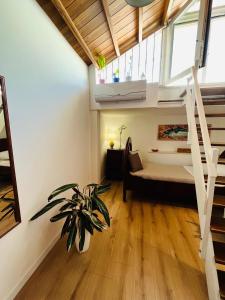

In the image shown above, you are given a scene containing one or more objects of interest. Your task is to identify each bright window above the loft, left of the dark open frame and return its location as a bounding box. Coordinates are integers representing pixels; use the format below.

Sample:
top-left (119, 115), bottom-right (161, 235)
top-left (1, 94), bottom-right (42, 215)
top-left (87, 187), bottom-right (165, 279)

top-left (170, 1), bottom-right (200, 77)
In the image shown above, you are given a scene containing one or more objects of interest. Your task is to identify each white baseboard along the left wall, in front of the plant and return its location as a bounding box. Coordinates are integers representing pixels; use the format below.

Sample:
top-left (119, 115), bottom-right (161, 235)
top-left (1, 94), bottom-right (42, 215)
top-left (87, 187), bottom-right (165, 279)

top-left (6, 234), bottom-right (59, 300)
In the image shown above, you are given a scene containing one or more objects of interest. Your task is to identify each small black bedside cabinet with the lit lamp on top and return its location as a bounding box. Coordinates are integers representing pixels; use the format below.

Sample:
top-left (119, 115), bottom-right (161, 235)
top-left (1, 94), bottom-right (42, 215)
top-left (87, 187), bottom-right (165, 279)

top-left (106, 149), bottom-right (124, 179)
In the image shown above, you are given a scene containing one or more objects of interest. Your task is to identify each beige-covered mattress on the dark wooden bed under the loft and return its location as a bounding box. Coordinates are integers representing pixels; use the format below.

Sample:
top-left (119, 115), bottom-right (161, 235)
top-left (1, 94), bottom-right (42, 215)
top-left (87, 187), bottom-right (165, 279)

top-left (130, 162), bottom-right (194, 184)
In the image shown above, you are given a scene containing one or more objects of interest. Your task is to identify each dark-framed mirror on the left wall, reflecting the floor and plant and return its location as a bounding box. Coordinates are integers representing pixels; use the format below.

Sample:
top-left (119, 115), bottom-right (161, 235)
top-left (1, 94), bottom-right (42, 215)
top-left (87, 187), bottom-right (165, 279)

top-left (0, 76), bottom-right (21, 237)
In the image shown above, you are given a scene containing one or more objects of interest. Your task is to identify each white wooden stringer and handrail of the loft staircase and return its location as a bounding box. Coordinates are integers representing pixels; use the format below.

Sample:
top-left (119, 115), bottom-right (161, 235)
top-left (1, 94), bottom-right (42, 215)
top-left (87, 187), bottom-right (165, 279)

top-left (180, 67), bottom-right (225, 300)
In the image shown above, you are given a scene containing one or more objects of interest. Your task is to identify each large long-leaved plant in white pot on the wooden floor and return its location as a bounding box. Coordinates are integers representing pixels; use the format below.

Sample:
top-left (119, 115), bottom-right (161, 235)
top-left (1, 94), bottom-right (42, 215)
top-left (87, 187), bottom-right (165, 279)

top-left (31, 183), bottom-right (110, 252)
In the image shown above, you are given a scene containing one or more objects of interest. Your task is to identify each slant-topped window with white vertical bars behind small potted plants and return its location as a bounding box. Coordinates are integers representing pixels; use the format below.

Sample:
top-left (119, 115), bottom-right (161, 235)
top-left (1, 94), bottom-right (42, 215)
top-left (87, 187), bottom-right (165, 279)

top-left (96, 31), bottom-right (162, 84)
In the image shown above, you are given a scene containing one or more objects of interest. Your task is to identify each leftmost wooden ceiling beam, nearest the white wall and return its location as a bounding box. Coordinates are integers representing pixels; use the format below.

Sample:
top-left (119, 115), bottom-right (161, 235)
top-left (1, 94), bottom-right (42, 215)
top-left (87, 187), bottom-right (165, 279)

top-left (51, 0), bottom-right (98, 68)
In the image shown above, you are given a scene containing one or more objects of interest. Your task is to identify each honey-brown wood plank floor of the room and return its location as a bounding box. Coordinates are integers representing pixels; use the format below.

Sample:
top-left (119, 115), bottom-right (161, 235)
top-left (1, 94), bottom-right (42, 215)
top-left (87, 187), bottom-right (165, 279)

top-left (16, 183), bottom-right (208, 300)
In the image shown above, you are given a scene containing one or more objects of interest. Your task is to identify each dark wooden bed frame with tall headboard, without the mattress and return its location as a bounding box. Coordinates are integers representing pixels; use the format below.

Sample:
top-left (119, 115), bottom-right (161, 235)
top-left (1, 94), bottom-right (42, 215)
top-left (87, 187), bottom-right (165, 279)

top-left (123, 137), bottom-right (197, 206)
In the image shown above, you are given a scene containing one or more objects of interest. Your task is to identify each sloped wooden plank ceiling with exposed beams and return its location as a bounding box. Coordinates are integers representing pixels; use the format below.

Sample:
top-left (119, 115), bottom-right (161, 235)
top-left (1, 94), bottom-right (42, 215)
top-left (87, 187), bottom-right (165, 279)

top-left (37, 0), bottom-right (190, 66)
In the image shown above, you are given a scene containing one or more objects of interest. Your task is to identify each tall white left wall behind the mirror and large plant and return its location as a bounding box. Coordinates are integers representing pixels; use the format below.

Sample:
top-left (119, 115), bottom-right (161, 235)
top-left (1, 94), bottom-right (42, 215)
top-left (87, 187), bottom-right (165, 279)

top-left (0, 0), bottom-right (90, 300)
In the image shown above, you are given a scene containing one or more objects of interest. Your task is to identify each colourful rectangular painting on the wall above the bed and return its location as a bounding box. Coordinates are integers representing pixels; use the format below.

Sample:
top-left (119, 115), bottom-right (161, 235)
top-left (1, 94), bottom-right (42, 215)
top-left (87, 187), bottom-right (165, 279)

top-left (158, 124), bottom-right (188, 141)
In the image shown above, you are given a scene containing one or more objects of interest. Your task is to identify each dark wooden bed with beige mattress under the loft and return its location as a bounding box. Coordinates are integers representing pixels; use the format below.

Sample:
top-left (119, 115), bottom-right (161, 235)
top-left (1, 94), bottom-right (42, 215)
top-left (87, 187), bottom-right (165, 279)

top-left (123, 137), bottom-right (197, 205)
